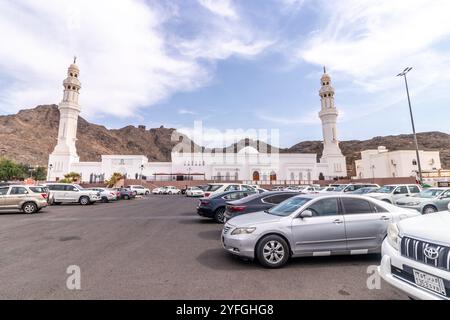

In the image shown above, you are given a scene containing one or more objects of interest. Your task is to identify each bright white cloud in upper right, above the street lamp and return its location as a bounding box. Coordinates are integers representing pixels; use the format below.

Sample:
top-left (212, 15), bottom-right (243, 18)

top-left (297, 0), bottom-right (450, 94)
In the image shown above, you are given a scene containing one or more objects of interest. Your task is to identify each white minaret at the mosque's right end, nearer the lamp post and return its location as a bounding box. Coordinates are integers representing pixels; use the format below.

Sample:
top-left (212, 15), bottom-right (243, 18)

top-left (319, 67), bottom-right (347, 178)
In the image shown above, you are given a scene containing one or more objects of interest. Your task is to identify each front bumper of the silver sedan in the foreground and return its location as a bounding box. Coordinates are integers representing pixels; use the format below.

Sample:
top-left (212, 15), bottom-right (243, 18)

top-left (222, 228), bottom-right (257, 259)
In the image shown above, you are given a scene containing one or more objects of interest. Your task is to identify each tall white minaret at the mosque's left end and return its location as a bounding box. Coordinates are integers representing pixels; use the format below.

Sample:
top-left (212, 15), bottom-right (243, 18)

top-left (47, 58), bottom-right (81, 181)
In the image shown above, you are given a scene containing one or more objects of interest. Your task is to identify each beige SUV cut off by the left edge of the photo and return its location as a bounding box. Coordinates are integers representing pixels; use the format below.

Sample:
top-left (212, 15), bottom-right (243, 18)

top-left (0, 185), bottom-right (48, 214)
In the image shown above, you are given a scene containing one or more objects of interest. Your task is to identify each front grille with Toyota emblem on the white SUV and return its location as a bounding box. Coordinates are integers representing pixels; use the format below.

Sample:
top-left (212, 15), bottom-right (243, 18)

top-left (400, 237), bottom-right (450, 271)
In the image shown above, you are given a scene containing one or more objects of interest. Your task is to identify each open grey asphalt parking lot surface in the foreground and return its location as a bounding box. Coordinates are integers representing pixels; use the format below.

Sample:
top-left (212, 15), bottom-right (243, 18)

top-left (0, 196), bottom-right (406, 300)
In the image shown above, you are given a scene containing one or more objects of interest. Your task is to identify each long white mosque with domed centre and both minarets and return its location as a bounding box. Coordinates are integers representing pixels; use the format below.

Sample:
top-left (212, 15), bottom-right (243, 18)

top-left (47, 61), bottom-right (347, 183)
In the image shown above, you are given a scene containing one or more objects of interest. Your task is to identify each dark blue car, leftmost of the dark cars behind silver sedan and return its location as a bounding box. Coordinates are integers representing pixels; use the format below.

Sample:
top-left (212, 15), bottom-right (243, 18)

top-left (197, 190), bottom-right (255, 223)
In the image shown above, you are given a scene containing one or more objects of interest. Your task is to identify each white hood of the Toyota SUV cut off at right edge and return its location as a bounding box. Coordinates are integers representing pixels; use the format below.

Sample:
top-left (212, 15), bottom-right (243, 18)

top-left (398, 211), bottom-right (450, 245)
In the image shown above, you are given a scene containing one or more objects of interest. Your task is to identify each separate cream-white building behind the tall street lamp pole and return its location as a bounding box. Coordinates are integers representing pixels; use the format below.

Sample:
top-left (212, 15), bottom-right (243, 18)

top-left (355, 147), bottom-right (441, 179)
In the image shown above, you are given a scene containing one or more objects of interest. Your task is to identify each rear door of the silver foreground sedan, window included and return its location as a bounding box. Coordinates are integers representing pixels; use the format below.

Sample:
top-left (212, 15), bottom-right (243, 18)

top-left (341, 197), bottom-right (392, 253)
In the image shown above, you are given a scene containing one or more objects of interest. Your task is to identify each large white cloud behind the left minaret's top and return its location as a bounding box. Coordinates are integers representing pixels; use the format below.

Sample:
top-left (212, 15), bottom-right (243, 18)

top-left (0, 0), bottom-right (265, 117)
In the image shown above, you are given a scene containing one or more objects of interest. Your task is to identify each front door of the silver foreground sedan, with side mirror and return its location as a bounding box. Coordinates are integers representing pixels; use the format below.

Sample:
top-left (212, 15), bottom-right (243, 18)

top-left (292, 197), bottom-right (346, 256)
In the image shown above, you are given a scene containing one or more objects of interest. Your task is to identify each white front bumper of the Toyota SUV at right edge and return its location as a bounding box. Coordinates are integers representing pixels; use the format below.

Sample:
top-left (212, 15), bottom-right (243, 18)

top-left (378, 240), bottom-right (450, 300)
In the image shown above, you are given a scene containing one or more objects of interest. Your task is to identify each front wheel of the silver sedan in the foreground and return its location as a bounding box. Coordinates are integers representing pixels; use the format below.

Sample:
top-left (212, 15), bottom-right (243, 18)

top-left (256, 235), bottom-right (290, 268)
